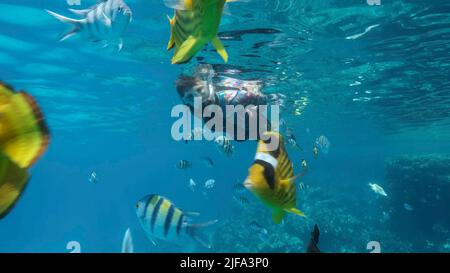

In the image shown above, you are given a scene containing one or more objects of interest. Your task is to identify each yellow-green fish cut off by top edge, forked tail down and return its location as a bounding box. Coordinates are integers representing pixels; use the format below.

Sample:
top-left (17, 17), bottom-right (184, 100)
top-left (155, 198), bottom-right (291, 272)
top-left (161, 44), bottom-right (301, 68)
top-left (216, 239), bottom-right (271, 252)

top-left (165, 0), bottom-right (236, 64)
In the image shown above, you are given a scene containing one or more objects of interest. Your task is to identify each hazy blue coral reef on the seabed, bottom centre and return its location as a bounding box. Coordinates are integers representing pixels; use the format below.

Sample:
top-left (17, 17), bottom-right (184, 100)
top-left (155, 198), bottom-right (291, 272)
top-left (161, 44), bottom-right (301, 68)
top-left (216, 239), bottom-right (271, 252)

top-left (213, 184), bottom-right (412, 253)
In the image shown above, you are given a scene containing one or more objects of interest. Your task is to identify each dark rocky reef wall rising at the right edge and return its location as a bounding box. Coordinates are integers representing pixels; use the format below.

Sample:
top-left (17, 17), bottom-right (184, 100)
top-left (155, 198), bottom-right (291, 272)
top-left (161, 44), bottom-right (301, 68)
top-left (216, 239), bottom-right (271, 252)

top-left (383, 155), bottom-right (450, 252)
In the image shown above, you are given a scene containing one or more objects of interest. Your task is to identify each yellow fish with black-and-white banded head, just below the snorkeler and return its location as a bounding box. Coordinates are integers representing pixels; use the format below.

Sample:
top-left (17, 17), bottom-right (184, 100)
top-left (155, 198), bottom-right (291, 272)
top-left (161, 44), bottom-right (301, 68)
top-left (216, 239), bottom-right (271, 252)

top-left (244, 132), bottom-right (305, 224)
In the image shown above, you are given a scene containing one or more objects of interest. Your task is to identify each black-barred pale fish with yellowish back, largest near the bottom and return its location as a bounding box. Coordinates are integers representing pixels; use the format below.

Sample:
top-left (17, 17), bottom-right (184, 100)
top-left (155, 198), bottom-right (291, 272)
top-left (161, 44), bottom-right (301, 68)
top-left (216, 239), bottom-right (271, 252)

top-left (136, 194), bottom-right (217, 248)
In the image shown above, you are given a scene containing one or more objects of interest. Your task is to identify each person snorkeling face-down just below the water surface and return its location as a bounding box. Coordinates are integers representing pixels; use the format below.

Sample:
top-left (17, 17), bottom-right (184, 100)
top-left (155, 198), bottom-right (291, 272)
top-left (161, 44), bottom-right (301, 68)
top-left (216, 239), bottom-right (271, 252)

top-left (176, 65), bottom-right (278, 141)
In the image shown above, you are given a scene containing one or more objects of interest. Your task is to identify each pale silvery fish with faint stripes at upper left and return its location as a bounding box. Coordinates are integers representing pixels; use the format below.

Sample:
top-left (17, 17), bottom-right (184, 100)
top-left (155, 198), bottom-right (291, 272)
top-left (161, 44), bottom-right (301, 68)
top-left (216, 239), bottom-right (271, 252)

top-left (46, 0), bottom-right (132, 51)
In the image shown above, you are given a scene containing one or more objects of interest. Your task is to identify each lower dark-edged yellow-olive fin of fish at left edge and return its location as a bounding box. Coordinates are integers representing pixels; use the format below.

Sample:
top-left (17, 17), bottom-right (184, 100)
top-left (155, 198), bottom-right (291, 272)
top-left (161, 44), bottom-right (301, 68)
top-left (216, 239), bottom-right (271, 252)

top-left (0, 153), bottom-right (29, 219)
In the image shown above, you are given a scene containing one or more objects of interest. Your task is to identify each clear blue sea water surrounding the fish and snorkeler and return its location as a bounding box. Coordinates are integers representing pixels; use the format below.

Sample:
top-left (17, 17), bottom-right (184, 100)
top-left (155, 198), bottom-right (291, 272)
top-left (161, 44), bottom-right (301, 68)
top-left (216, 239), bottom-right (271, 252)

top-left (0, 0), bottom-right (450, 252)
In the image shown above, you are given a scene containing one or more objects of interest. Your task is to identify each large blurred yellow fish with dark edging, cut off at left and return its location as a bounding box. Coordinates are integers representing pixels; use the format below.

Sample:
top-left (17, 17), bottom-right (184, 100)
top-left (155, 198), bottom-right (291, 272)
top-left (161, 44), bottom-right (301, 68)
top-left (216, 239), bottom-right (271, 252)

top-left (0, 82), bottom-right (50, 218)
